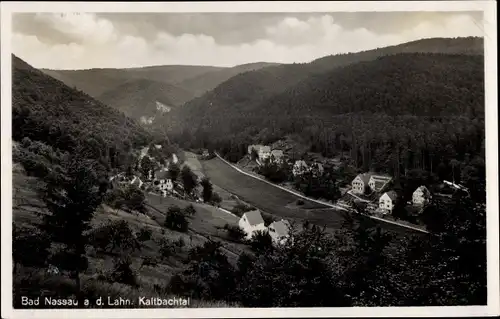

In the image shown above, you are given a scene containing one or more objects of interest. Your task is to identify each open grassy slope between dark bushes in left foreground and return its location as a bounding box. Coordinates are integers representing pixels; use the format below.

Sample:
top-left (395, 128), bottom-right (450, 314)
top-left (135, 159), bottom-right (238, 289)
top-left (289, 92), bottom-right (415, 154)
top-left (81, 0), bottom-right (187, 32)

top-left (13, 163), bottom-right (248, 307)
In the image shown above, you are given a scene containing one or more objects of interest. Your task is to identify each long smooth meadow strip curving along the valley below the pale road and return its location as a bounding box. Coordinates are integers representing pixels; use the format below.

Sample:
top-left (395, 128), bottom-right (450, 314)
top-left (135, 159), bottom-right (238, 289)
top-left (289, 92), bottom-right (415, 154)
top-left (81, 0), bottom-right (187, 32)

top-left (202, 158), bottom-right (424, 238)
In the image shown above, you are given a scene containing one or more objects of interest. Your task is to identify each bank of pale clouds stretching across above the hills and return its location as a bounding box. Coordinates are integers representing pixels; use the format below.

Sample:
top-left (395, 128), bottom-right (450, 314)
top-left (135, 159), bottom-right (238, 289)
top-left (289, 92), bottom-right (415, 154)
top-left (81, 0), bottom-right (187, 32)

top-left (12, 13), bottom-right (482, 69)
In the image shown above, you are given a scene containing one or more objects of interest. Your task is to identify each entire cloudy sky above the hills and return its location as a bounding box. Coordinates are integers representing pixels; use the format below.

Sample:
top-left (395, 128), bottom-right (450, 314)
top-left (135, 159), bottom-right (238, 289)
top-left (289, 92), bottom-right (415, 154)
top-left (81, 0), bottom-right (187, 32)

top-left (12, 12), bottom-right (483, 69)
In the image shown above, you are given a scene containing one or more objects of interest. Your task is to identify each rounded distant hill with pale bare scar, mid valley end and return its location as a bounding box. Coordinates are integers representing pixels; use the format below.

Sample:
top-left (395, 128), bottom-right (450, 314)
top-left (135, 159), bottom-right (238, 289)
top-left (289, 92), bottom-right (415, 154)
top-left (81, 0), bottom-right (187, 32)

top-left (97, 79), bottom-right (192, 119)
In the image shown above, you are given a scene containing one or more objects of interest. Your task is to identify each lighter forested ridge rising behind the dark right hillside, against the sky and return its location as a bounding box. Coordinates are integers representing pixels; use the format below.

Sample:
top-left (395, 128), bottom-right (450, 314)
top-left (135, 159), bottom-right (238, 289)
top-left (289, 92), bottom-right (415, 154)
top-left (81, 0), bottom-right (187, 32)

top-left (169, 37), bottom-right (483, 131)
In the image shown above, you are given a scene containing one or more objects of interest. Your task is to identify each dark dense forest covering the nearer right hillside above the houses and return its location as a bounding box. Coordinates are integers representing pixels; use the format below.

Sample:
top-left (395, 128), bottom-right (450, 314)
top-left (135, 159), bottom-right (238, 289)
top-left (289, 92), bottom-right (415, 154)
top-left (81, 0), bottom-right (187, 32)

top-left (170, 54), bottom-right (485, 204)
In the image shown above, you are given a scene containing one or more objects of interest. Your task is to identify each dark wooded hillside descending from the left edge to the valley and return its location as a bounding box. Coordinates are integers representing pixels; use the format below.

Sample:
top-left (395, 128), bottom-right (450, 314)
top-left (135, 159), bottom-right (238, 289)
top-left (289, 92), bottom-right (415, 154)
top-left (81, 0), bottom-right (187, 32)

top-left (12, 55), bottom-right (152, 170)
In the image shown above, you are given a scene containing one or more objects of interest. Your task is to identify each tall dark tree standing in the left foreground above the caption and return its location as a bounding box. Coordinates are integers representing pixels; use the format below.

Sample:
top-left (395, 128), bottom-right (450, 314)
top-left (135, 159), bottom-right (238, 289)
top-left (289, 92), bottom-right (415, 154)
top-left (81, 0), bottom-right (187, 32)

top-left (41, 155), bottom-right (104, 303)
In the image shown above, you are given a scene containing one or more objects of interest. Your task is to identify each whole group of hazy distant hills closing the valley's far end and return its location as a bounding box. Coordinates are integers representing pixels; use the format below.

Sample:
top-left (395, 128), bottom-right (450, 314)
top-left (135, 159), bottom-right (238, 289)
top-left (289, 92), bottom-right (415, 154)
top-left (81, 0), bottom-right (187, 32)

top-left (43, 62), bottom-right (276, 119)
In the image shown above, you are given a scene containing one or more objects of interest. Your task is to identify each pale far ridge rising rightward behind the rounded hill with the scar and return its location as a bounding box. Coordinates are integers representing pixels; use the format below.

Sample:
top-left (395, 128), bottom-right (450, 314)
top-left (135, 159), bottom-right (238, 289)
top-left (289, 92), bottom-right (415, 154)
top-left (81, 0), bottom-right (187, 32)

top-left (178, 62), bottom-right (278, 96)
